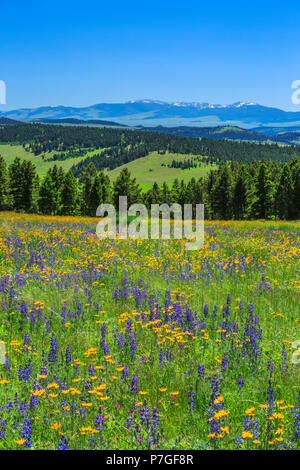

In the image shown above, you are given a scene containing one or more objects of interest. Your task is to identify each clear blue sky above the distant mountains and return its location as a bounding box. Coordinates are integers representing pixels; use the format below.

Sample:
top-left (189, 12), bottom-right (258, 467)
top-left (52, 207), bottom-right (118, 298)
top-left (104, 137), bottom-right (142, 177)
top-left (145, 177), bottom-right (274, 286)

top-left (0, 0), bottom-right (300, 112)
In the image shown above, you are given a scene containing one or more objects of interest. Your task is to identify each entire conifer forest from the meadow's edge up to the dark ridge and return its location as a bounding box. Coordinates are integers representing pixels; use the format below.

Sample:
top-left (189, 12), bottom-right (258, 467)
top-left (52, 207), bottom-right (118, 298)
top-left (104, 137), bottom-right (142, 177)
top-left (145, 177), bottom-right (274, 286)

top-left (0, 124), bottom-right (300, 219)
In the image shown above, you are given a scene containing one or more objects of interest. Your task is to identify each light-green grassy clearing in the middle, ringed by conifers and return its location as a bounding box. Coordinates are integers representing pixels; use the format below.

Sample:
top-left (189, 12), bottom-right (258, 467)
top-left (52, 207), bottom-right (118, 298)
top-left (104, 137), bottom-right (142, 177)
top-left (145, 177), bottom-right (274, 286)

top-left (108, 152), bottom-right (216, 190)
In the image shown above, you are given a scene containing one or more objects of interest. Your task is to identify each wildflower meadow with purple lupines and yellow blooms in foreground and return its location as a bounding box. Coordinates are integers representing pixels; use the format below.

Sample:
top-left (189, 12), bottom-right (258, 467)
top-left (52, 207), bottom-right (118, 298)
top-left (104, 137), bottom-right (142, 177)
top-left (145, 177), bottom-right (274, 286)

top-left (0, 212), bottom-right (300, 450)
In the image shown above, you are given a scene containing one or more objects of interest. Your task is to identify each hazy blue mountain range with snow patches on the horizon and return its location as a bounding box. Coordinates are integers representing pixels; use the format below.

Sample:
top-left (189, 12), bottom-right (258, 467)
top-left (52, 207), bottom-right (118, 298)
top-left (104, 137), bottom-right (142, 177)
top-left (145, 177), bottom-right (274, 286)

top-left (0, 100), bottom-right (300, 129)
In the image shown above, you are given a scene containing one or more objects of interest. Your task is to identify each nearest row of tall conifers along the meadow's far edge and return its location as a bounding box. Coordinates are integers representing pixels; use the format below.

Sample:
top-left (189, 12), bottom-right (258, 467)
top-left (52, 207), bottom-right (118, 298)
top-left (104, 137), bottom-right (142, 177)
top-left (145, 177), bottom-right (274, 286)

top-left (0, 156), bottom-right (300, 220)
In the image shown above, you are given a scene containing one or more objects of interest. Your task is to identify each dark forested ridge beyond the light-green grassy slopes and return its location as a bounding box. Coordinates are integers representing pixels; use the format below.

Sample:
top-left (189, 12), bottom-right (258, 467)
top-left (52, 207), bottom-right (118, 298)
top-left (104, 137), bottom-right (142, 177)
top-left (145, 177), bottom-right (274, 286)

top-left (0, 123), bottom-right (300, 170)
